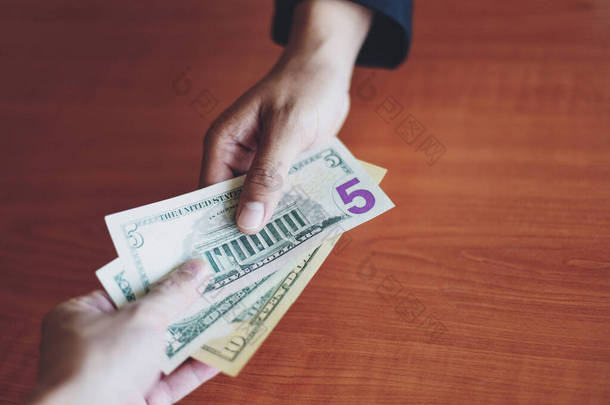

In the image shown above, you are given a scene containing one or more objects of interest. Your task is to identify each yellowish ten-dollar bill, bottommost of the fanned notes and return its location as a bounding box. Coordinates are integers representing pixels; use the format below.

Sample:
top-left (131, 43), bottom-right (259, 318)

top-left (192, 162), bottom-right (386, 377)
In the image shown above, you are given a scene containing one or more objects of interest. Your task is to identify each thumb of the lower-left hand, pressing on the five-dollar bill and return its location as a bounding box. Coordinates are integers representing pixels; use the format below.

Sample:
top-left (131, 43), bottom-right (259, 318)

top-left (138, 259), bottom-right (212, 329)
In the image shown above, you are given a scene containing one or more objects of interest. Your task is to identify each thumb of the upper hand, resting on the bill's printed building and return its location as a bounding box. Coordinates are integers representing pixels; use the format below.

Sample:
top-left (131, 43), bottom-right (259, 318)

top-left (237, 123), bottom-right (300, 234)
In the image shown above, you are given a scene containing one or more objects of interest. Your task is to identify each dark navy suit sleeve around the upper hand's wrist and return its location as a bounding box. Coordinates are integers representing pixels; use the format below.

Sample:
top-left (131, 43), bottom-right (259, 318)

top-left (271, 0), bottom-right (413, 68)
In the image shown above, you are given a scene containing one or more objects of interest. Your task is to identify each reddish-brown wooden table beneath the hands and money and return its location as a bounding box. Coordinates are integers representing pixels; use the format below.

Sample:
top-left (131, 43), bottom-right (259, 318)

top-left (0, 0), bottom-right (610, 404)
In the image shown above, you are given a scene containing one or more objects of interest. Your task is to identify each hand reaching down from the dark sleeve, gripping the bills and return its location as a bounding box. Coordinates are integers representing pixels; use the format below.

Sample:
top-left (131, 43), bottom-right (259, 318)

top-left (200, 0), bottom-right (372, 234)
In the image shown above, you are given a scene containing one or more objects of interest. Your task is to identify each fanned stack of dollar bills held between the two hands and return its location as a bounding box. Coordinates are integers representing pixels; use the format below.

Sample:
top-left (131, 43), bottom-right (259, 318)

top-left (96, 138), bottom-right (394, 376)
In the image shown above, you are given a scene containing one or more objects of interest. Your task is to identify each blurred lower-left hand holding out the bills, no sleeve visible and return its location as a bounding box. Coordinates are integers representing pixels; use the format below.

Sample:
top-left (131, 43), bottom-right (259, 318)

top-left (29, 260), bottom-right (218, 405)
